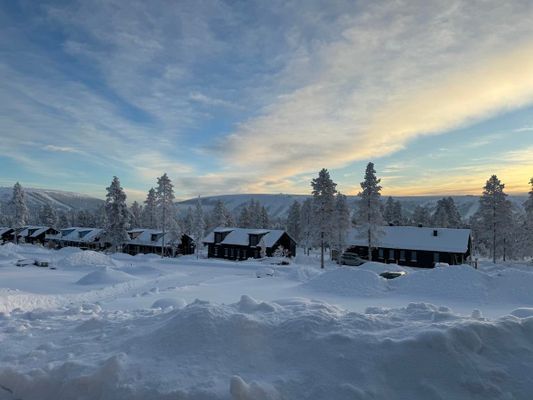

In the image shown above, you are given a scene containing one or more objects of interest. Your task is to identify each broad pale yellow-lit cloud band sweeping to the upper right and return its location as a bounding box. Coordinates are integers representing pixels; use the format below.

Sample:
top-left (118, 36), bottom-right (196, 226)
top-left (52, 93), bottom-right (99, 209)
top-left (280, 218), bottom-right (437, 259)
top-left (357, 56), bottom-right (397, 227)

top-left (216, 2), bottom-right (533, 191)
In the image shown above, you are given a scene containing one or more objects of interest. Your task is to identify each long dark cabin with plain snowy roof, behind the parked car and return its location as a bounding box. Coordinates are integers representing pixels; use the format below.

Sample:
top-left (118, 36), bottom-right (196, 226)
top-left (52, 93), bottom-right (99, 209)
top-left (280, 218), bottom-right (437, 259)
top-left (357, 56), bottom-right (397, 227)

top-left (347, 226), bottom-right (472, 268)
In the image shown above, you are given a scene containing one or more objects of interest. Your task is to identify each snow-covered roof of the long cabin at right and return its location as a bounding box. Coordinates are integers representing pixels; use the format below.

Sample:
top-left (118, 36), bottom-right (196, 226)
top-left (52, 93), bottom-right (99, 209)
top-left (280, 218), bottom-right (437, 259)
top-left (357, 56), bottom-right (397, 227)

top-left (347, 226), bottom-right (470, 253)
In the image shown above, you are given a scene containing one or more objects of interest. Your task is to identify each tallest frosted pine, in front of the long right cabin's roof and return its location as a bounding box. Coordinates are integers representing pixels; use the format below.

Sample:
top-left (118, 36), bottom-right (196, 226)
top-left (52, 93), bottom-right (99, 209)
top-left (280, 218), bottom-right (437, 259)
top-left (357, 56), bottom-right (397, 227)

top-left (356, 162), bottom-right (383, 261)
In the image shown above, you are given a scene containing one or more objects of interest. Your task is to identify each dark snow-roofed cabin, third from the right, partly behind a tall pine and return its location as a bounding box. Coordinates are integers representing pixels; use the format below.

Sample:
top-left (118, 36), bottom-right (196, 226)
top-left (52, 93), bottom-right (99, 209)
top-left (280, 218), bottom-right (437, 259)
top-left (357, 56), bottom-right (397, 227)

top-left (122, 228), bottom-right (195, 256)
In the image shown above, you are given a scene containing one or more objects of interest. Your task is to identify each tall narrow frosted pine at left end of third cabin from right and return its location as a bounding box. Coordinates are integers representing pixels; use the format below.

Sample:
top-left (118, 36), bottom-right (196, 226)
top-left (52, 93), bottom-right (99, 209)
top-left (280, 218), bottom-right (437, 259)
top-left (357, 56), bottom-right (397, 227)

top-left (103, 176), bottom-right (129, 251)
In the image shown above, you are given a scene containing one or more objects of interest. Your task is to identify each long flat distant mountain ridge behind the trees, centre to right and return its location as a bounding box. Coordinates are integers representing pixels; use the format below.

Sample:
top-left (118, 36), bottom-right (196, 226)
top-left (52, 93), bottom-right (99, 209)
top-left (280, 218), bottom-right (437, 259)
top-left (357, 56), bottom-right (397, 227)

top-left (177, 193), bottom-right (527, 219)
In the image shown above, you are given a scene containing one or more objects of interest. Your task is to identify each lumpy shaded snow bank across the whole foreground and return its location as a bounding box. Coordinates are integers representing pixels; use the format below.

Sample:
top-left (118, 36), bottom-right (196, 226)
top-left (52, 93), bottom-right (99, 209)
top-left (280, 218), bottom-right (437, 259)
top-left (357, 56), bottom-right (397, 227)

top-left (0, 296), bottom-right (533, 400)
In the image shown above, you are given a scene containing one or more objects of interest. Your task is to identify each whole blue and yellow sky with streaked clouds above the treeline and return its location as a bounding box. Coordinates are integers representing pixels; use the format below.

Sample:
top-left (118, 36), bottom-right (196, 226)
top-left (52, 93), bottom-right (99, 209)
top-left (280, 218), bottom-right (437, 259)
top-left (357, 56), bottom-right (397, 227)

top-left (0, 0), bottom-right (533, 200)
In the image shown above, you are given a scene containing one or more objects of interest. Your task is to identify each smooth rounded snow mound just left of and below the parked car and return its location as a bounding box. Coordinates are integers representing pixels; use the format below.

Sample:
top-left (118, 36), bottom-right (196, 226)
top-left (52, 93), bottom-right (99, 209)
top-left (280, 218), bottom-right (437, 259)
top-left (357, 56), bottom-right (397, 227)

top-left (301, 267), bottom-right (387, 296)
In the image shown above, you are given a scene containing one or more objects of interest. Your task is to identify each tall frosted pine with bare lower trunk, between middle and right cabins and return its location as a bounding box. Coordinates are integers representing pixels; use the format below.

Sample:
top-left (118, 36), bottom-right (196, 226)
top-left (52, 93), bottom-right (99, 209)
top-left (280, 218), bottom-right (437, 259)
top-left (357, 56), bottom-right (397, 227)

top-left (311, 168), bottom-right (337, 268)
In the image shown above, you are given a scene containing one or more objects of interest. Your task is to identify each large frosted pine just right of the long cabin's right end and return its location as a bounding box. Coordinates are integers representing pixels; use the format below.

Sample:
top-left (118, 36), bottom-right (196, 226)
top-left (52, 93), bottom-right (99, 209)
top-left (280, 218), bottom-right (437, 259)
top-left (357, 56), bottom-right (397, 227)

top-left (473, 175), bottom-right (513, 263)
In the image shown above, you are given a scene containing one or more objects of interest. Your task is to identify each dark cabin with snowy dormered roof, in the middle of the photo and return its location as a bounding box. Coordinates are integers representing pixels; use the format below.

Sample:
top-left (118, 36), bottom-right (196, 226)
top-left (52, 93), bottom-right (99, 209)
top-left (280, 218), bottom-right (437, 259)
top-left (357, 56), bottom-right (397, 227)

top-left (203, 227), bottom-right (296, 260)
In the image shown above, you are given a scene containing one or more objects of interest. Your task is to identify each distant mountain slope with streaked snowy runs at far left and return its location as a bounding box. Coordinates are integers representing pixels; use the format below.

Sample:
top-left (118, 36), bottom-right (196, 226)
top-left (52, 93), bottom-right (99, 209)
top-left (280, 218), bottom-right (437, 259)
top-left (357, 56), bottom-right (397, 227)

top-left (0, 187), bottom-right (104, 211)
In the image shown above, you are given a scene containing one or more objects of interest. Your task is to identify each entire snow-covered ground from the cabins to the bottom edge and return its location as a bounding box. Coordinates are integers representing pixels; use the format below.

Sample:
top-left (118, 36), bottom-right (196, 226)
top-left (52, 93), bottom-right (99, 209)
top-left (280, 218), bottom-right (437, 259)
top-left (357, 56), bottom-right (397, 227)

top-left (0, 244), bottom-right (533, 400)
